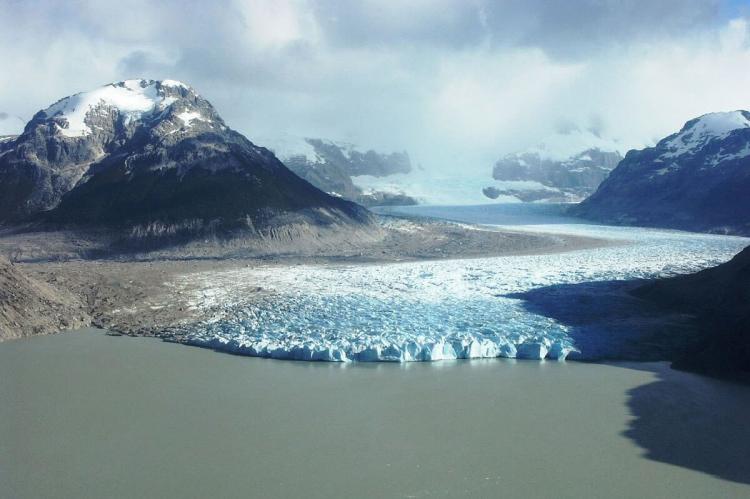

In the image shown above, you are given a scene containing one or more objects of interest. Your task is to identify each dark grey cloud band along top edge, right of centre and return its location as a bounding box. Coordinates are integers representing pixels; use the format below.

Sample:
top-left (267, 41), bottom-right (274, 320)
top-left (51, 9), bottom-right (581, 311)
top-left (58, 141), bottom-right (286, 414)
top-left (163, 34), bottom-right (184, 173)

top-left (316, 0), bottom-right (721, 58)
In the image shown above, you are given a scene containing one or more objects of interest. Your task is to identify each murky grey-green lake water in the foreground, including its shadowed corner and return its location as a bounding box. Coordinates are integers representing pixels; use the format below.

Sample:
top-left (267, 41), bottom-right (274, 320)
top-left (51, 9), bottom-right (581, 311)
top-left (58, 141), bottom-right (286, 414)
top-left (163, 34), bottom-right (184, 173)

top-left (0, 330), bottom-right (750, 498)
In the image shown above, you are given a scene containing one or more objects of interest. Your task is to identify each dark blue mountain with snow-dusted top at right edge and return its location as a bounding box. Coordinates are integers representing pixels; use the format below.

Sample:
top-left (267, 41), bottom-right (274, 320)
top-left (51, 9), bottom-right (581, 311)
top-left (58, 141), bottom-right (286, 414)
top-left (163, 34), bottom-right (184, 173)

top-left (572, 111), bottom-right (750, 234)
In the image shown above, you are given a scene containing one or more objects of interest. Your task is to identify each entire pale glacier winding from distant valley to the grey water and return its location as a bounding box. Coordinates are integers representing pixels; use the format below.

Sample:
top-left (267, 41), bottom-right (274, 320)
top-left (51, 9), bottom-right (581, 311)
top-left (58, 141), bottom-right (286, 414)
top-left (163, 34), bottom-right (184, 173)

top-left (179, 204), bottom-right (750, 362)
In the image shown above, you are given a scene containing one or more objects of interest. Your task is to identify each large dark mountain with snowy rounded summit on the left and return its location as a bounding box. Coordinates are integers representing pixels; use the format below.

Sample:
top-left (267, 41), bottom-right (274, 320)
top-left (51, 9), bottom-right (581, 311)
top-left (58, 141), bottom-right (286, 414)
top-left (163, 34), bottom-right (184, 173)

top-left (0, 80), bottom-right (369, 238)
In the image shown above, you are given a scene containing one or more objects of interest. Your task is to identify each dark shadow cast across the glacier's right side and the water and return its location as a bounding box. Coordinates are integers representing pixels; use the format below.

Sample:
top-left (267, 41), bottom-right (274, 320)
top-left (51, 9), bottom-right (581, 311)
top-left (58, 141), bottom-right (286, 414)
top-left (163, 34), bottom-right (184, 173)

top-left (509, 281), bottom-right (750, 484)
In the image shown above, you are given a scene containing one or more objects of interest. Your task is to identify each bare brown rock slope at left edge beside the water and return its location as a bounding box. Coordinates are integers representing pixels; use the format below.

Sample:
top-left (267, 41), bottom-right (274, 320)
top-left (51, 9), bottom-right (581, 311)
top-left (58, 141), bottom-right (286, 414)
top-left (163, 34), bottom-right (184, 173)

top-left (0, 257), bottom-right (90, 341)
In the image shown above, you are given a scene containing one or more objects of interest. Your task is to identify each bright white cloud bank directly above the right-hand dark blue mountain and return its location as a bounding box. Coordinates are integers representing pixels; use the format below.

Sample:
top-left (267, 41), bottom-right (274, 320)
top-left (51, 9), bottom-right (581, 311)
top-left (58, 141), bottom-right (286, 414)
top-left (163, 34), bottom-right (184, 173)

top-left (577, 15), bottom-right (750, 147)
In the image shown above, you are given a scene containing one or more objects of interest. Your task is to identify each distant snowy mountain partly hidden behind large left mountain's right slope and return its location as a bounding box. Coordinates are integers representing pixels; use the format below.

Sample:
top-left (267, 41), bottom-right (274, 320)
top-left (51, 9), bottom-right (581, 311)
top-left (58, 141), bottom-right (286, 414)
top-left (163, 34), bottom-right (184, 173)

top-left (264, 137), bottom-right (416, 206)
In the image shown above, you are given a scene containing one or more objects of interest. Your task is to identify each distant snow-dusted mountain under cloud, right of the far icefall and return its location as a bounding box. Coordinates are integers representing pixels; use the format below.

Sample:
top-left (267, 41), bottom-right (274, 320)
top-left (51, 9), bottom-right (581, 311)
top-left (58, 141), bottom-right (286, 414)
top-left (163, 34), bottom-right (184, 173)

top-left (484, 130), bottom-right (622, 202)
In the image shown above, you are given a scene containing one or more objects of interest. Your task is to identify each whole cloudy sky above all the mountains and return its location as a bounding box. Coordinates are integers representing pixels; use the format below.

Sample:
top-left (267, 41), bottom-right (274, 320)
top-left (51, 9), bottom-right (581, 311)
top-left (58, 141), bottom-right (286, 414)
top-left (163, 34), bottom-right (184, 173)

top-left (0, 0), bottom-right (750, 175)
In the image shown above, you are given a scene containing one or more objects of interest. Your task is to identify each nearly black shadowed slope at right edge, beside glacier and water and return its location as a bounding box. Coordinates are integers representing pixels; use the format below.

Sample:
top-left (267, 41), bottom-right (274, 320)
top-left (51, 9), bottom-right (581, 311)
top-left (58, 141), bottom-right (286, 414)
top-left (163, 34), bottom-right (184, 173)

top-left (633, 247), bottom-right (750, 374)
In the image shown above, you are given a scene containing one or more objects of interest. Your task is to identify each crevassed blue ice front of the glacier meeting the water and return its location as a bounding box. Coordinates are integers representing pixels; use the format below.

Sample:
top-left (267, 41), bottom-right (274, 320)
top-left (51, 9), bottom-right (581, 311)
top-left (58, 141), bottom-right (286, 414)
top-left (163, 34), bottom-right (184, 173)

top-left (189, 293), bottom-right (573, 362)
